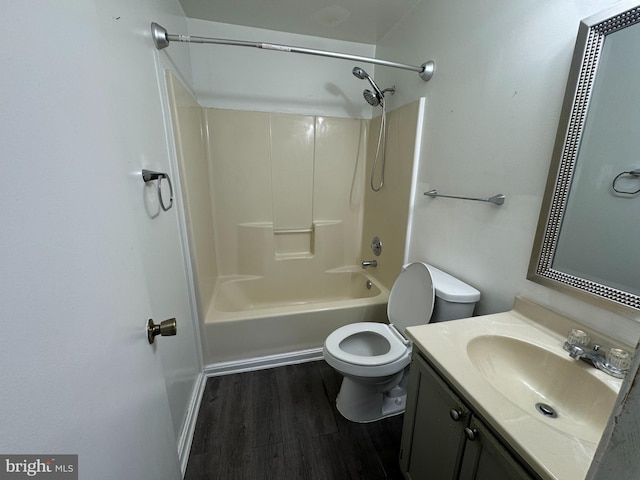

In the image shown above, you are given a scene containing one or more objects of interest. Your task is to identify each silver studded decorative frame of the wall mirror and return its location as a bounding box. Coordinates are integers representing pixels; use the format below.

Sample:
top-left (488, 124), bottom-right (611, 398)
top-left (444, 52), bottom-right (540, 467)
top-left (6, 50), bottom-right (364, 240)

top-left (527, 0), bottom-right (640, 317)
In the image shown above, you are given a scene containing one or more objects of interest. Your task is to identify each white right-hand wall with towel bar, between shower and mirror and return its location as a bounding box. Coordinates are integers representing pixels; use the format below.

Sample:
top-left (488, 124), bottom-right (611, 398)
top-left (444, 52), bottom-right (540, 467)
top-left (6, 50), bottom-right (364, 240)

top-left (376, 0), bottom-right (638, 343)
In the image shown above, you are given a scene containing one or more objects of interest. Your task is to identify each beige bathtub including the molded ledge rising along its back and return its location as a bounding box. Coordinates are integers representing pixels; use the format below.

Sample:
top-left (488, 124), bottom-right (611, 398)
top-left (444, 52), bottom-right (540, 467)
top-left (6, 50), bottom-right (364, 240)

top-left (196, 222), bottom-right (389, 363)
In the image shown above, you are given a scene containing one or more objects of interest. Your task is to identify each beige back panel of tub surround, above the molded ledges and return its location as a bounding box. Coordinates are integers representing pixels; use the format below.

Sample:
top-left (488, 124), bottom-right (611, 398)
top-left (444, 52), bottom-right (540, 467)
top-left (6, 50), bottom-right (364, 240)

top-left (206, 109), bottom-right (366, 275)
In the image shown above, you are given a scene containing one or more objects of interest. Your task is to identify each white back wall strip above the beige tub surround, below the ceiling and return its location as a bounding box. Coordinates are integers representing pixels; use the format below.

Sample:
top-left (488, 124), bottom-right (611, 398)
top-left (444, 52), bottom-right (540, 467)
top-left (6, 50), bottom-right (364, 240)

top-left (184, 19), bottom-right (375, 118)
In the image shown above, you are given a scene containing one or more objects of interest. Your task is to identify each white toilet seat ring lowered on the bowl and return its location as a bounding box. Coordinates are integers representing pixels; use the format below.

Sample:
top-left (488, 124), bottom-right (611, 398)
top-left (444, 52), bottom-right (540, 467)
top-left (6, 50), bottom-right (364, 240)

top-left (325, 322), bottom-right (408, 367)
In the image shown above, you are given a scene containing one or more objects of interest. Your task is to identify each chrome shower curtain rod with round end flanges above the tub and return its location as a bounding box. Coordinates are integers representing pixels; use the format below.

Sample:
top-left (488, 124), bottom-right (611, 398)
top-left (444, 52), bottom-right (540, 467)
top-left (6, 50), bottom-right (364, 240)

top-left (151, 22), bottom-right (436, 82)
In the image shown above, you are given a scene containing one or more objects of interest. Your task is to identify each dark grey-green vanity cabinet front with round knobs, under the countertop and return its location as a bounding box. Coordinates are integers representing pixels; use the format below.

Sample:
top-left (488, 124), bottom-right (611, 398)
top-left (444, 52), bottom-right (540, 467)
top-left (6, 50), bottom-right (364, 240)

top-left (400, 350), bottom-right (538, 480)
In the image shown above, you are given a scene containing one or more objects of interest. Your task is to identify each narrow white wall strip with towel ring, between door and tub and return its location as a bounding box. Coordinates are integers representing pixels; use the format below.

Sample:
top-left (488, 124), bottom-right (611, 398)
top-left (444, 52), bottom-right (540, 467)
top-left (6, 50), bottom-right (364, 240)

top-left (92, 0), bottom-right (202, 466)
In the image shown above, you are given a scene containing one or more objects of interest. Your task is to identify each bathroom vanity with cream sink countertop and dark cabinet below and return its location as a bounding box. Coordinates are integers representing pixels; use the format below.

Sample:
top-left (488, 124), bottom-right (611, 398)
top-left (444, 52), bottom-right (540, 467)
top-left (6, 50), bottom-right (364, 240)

top-left (400, 298), bottom-right (622, 480)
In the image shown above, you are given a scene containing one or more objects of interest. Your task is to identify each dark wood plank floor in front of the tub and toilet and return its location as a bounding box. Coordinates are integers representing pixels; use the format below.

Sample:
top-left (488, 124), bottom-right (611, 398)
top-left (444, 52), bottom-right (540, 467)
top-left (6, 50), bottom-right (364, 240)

top-left (185, 361), bottom-right (402, 480)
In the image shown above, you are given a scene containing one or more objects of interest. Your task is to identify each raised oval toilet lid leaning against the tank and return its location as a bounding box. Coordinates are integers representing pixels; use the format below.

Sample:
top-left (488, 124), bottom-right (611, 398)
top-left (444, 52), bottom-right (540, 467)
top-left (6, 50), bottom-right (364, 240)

top-left (387, 262), bottom-right (435, 335)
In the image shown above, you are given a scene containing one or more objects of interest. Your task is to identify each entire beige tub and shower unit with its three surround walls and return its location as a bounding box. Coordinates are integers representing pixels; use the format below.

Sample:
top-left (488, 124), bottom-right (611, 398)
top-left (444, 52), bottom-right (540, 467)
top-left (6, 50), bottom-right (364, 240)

top-left (167, 67), bottom-right (424, 372)
